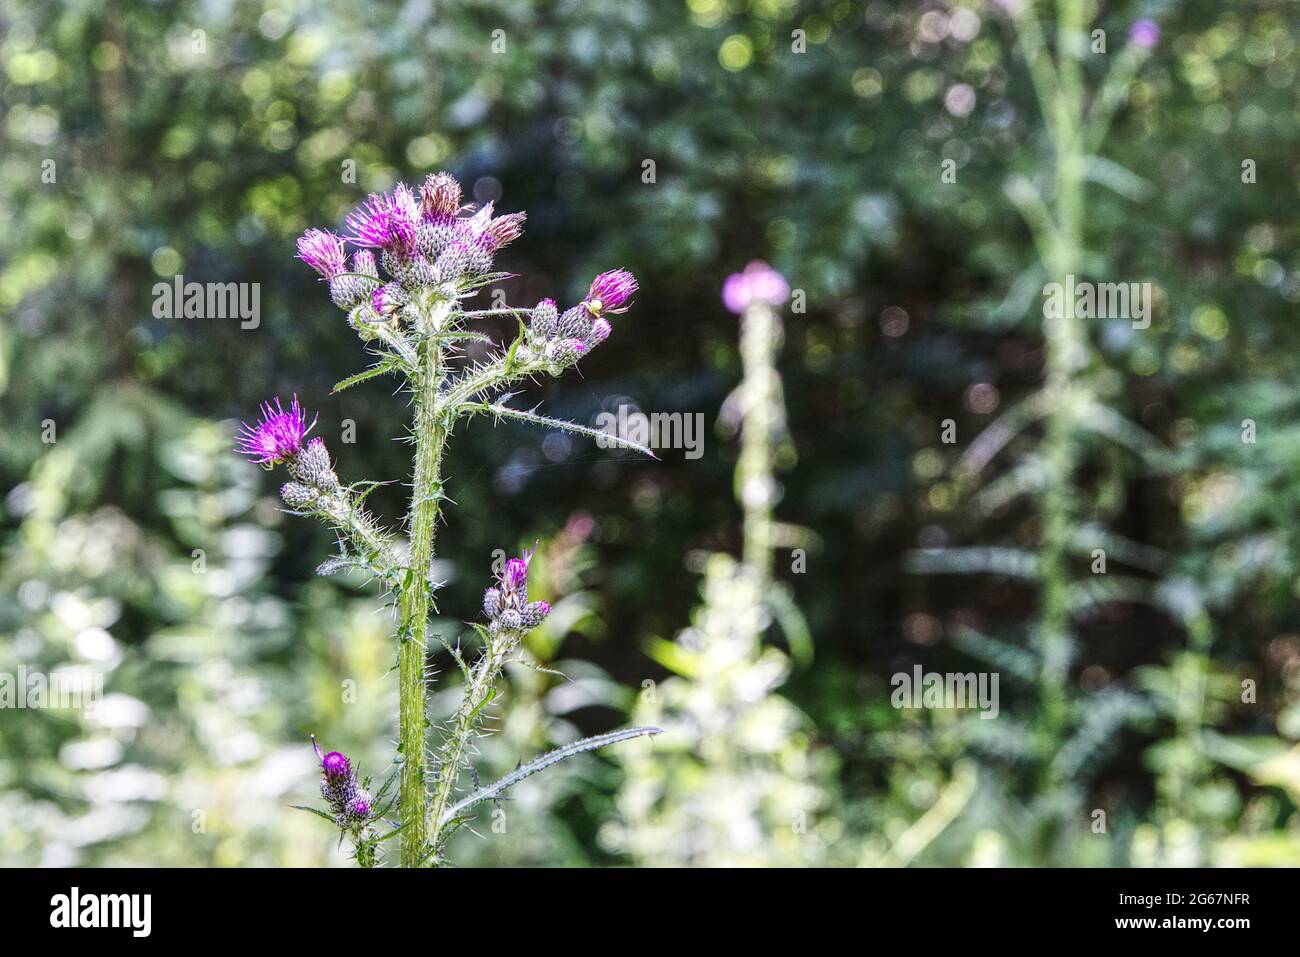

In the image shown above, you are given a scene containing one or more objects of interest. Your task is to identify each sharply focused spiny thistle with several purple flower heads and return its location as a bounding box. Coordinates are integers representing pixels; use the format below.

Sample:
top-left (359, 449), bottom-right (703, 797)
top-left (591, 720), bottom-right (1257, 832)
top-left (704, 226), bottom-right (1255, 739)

top-left (238, 173), bottom-right (657, 867)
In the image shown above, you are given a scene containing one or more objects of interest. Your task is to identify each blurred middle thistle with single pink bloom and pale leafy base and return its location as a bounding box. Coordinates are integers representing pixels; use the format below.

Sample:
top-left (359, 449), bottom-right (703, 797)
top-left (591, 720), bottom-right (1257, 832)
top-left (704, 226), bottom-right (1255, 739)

top-left (602, 263), bottom-right (833, 867)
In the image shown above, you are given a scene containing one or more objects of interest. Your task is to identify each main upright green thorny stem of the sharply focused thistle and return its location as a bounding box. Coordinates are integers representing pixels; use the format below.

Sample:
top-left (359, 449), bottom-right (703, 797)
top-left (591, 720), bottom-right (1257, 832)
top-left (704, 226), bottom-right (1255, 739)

top-left (398, 303), bottom-right (451, 867)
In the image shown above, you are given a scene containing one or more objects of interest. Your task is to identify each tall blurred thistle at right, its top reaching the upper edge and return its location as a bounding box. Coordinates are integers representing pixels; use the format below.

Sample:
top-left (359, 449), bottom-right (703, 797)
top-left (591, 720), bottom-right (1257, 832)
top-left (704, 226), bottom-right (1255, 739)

top-left (910, 0), bottom-right (1180, 854)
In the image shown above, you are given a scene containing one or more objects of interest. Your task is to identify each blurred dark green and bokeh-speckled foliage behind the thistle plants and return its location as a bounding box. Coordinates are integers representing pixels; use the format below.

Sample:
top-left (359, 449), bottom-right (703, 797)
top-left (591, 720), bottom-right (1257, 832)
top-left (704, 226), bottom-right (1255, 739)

top-left (0, 0), bottom-right (1300, 866)
